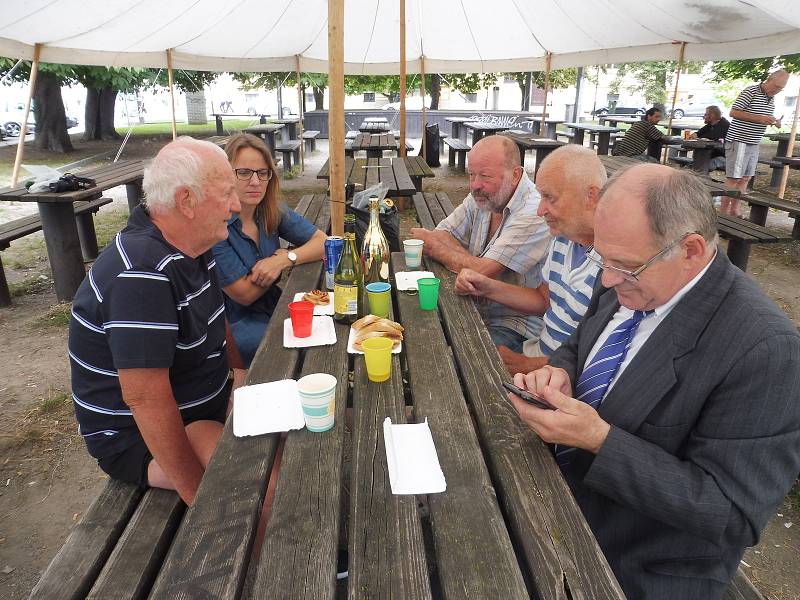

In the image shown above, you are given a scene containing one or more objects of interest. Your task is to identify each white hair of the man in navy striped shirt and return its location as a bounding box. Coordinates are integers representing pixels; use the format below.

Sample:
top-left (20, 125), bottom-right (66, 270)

top-left (142, 136), bottom-right (228, 213)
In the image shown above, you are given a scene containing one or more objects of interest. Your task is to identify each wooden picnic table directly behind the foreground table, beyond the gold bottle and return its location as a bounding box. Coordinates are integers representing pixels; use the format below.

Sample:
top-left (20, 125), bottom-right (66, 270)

top-left (317, 156), bottom-right (434, 197)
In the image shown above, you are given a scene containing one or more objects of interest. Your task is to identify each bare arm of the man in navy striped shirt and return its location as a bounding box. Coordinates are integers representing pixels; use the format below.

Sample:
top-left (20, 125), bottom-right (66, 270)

top-left (119, 369), bottom-right (203, 506)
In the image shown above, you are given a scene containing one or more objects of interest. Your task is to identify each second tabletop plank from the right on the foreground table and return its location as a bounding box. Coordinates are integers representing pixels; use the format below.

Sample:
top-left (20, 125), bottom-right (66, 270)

top-left (392, 252), bottom-right (529, 599)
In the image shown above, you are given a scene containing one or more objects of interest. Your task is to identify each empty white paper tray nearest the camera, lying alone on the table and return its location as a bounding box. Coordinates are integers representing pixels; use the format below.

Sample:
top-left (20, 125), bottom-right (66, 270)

top-left (383, 417), bottom-right (447, 495)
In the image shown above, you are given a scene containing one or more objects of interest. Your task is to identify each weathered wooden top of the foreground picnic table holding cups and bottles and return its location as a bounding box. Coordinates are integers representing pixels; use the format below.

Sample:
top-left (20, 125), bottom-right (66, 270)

top-left (145, 196), bottom-right (623, 600)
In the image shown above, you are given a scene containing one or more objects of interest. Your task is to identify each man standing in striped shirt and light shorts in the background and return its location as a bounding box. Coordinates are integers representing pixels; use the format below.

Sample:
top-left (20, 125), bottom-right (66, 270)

top-left (720, 69), bottom-right (789, 217)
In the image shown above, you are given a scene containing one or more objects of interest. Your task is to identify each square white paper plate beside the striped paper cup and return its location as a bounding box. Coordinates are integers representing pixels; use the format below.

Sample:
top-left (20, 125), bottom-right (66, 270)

top-left (233, 379), bottom-right (305, 437)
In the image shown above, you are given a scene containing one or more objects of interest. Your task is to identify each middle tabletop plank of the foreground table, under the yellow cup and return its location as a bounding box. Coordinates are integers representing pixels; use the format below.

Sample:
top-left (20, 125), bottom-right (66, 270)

top-left (347, 304), bottom-right (431, 600)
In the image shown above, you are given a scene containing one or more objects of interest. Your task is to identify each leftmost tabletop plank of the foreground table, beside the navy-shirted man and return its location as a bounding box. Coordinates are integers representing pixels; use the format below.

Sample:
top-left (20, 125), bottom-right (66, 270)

top-left (151, 262), bottom-right (322, 599)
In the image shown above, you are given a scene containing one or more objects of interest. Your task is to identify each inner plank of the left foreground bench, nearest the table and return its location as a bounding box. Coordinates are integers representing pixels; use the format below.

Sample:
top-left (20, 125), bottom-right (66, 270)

top-left (87, 488), bottom-right (186, 600)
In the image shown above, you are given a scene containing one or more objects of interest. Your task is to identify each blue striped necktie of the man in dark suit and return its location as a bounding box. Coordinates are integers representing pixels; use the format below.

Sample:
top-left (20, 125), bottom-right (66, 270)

top-left (554, 310), bottom-right (653, 468)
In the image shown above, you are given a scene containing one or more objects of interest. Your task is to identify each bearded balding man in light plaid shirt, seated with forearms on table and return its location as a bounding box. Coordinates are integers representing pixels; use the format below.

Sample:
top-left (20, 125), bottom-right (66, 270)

top-left (411, 135), bottom-right (551, 352)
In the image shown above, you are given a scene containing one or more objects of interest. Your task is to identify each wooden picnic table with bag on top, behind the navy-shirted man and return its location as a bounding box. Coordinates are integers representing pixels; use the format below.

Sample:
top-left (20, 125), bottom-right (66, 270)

top-left (0, 160), bottom-right (144, 301)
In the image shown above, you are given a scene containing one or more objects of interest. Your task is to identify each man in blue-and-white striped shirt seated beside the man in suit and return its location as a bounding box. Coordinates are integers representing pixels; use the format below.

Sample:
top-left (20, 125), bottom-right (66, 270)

top-left (456, 144), bottom-right (606, 375)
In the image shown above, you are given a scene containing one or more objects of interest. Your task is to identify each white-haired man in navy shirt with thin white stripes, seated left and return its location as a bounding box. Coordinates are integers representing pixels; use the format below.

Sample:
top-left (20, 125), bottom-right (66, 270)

top-left (69, 138), bottom-right (243, 505)
